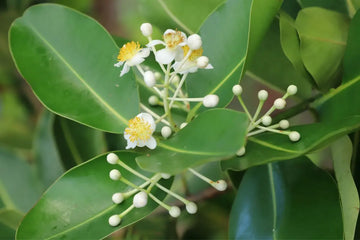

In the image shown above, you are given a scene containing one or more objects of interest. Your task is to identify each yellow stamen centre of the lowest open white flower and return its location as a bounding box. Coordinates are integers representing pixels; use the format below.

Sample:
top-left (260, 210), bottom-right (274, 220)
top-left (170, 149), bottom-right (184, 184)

top-left (125, 117), bottom-right (153, 142)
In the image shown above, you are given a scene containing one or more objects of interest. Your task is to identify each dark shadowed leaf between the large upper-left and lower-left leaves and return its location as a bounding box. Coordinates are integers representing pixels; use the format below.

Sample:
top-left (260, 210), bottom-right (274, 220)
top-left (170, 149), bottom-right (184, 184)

top-left (53, 116), bottom-right (106, 169)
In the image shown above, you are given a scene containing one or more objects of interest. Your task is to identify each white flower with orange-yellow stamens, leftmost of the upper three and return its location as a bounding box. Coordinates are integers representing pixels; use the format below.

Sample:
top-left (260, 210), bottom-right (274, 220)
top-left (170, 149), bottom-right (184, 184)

top-left (114, 41), bottom-right (150, 77)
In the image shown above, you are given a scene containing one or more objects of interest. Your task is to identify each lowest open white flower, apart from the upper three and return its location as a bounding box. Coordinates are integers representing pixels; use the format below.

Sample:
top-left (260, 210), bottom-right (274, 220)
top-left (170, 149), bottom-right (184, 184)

top-left (124, 113), bottom-right (156, 149)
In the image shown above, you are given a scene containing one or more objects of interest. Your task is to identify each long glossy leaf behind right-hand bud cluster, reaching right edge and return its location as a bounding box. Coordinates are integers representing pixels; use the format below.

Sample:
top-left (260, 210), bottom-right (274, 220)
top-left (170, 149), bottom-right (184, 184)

top-left (221, 116), bottom-right (360, 170)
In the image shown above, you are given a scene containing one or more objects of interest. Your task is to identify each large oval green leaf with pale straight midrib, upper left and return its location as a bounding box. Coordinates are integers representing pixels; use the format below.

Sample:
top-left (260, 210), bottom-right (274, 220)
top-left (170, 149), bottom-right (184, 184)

top-left (9, 4), bottom-right (139, 133)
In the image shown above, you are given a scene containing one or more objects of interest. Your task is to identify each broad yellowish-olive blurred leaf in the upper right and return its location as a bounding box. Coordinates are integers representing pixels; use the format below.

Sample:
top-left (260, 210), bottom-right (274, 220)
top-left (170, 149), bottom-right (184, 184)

top-left (295, 7), bottom-right (349, 90)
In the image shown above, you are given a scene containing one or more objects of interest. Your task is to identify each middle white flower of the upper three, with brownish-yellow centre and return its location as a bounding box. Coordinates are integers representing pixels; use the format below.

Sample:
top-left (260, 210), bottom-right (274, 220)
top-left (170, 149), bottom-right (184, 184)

top-left (146, 29), bottom-right (187, 64)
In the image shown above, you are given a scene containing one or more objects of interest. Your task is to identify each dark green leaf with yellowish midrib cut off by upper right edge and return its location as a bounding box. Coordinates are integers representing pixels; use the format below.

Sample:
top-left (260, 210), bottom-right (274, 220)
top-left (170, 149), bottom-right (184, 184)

top-left (314, 12), bottom-right (360, 121)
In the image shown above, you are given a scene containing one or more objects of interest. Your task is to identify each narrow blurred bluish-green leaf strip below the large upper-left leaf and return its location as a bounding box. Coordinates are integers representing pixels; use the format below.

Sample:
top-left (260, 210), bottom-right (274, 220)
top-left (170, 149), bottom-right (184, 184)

top-left (33, 110), bottom-right (64, 189)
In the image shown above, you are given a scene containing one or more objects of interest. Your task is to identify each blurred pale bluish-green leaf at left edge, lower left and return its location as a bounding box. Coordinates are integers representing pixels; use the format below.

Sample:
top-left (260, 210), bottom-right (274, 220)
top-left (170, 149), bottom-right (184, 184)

top-left (0, 148), bottom-right (42, 212)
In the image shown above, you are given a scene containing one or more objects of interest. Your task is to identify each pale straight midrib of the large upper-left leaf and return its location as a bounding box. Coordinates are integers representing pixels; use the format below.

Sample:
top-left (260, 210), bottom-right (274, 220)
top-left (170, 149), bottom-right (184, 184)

top-left (24, 24), bottom-right (128, 125)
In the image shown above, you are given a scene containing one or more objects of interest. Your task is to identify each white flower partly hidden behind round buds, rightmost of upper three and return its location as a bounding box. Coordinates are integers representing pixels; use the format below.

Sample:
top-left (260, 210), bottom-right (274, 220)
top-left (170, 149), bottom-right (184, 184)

top-left (173, 45), bottom-right (214, 74)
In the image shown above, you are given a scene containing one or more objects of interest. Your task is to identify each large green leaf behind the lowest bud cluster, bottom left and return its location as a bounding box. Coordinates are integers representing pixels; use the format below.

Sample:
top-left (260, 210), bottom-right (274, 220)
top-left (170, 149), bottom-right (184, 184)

top-left (16, 152), bottom-right (172, 239)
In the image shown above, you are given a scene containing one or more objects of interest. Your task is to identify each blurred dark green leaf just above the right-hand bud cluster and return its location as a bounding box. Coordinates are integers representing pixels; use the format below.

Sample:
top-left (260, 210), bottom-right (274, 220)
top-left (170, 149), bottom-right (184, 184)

top-left (246, 20), bottom-right (311, 100)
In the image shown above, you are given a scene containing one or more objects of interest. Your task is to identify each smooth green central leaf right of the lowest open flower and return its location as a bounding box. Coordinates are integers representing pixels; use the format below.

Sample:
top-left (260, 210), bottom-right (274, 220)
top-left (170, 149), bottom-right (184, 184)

top-left (136, 109), bottom-right (248, 174)
